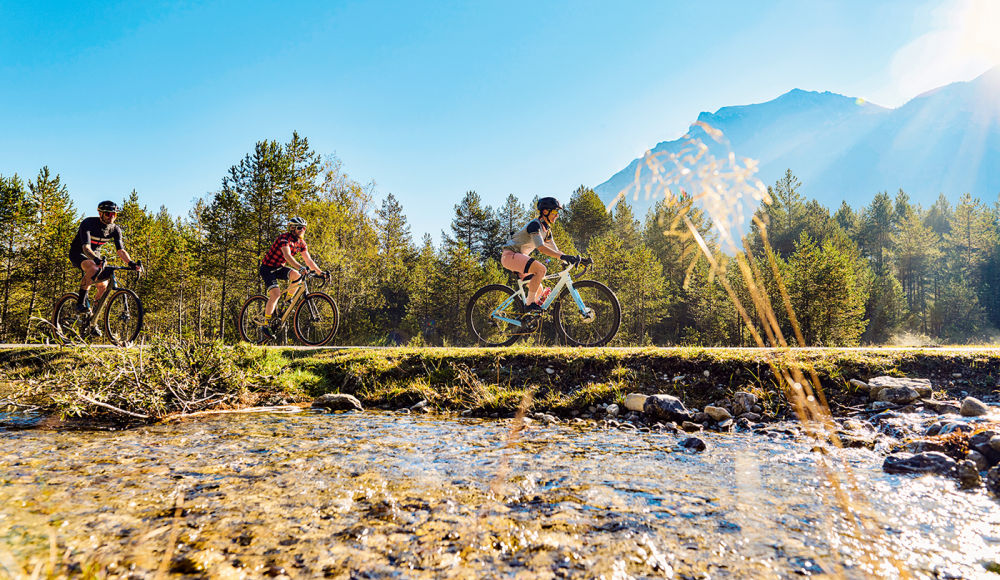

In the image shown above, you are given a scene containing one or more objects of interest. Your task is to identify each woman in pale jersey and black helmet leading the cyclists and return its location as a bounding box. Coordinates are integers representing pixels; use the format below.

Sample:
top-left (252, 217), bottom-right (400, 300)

top-left (500, 197), bottom-right (580, 312)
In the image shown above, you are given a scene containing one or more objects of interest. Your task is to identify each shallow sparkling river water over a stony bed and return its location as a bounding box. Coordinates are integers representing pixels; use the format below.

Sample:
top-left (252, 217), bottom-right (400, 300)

top-left (0, 412), bottom-right (1000, 580)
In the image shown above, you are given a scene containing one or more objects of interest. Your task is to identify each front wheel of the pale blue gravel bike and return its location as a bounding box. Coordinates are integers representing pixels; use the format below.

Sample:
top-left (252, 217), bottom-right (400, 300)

top-left (556, 280), bottom-right (622, 346)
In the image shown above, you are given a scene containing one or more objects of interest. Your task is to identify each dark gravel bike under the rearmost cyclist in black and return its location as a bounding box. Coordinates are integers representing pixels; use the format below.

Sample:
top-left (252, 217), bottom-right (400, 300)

top-left (52, 260), bottom-right (143, 346)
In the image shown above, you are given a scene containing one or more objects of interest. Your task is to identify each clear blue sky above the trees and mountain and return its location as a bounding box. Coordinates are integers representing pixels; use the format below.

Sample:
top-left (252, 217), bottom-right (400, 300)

top-left (0, 0), bottom-right (1000, 238)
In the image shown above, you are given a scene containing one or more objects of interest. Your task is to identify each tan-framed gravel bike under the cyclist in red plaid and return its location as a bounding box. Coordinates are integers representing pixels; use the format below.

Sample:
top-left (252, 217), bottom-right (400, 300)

top-left (239, 272), bottom-right (340, 346)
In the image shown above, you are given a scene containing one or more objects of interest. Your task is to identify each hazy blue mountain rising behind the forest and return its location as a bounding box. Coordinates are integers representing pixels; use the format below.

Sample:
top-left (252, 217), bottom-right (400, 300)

top-left (594, 66), bottom-right (1000, 216)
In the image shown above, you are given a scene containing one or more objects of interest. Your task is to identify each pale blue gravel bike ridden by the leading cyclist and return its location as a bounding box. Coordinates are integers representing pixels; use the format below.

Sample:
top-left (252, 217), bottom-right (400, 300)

top-left (465, 258), bottom-right (622, 346)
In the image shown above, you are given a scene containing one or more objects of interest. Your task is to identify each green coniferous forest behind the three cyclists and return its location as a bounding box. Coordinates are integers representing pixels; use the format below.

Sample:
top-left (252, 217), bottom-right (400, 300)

top-left (0, 133), bottom-right (1000, 346)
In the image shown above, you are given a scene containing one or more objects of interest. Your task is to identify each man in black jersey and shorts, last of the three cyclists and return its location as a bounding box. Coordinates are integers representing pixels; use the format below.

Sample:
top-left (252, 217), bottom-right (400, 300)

top-left (69, 201), bottom-right (142, 312)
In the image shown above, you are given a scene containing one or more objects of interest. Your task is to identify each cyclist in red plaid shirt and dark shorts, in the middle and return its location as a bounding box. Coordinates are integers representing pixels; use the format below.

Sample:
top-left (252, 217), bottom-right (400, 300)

top-left (260, 217), bottom-right (329, 340)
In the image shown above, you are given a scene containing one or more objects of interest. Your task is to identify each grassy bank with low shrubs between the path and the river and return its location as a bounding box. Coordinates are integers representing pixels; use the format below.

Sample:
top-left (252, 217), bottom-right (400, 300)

top-left (0, 343), bottom-right (1000, 422)
